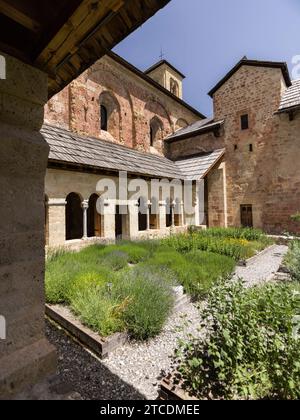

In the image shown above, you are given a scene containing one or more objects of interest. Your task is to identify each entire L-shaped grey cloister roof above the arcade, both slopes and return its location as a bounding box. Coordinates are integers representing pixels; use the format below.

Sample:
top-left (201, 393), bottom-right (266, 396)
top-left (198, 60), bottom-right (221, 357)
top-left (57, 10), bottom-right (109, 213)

top-left (41, 125), bottom-right (224, 180)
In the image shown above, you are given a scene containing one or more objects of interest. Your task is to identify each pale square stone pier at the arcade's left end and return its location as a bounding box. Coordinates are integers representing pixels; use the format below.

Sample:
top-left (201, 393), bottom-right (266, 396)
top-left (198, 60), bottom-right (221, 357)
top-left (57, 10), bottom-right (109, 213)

top-left (47, 198), bottom-right (67, 248)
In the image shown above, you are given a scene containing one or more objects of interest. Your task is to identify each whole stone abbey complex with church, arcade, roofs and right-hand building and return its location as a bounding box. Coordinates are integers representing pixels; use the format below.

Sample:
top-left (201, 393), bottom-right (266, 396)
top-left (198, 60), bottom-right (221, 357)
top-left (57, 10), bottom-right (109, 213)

top-left (42, 52), bottom-right (300, 247)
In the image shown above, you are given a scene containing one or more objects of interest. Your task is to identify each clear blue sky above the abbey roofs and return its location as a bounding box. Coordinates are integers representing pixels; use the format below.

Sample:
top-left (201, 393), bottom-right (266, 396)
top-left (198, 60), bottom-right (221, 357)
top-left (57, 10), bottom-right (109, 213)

top-left (115, 0), bottom-right (300, 116)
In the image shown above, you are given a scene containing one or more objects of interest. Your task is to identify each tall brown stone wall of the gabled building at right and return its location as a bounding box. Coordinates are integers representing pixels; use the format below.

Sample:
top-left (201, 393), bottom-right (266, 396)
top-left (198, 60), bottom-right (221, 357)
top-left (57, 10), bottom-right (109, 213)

top-left (214, 66), bottom-right (300, 233)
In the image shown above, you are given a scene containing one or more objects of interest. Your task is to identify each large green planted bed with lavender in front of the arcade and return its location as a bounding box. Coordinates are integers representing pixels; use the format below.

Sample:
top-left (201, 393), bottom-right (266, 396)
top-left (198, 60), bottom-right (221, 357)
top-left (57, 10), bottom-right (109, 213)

top-left (46, 229), bottom-right (270, 340)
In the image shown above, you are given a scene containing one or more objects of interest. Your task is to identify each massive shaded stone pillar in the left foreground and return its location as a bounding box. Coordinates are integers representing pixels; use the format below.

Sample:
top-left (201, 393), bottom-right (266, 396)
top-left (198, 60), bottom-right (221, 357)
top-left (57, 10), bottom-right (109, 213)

top-left (0, 53), bottom-right (56, 398)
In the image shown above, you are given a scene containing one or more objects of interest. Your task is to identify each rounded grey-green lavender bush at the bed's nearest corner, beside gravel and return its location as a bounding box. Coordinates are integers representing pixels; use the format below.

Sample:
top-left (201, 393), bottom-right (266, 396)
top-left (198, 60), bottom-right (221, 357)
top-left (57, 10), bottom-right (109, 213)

top-left (113, 267), bottom-right (174, 340)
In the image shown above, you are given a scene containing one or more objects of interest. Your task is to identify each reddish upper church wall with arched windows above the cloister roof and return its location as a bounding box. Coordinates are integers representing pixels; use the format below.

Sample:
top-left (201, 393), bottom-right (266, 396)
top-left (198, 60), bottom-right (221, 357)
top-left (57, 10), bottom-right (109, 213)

top-left (45, 56), bottom-right (199, 153)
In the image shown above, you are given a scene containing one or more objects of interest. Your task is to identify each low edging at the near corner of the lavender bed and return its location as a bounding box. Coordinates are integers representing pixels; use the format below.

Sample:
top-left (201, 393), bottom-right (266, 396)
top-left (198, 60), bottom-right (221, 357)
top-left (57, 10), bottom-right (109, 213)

top-left (46, 305), bottom-right (128, 359)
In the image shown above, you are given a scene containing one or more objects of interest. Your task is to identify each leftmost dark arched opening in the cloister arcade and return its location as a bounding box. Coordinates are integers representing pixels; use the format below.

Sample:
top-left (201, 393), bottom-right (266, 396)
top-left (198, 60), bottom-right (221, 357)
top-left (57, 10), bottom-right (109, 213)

top-left (66, 193), bottom-right (83, 241)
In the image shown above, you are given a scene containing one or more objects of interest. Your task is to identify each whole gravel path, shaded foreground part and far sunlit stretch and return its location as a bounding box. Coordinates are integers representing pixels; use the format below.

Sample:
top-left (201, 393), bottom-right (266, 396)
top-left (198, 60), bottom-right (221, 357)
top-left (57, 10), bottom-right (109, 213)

top-left (47, 246), bottom-right (288, 400)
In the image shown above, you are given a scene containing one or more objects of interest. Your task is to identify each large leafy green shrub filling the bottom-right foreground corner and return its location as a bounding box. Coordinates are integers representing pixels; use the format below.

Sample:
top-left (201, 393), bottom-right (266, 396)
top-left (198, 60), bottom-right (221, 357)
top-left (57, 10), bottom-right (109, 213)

top-left (177, 281), bottom-right (300, 399)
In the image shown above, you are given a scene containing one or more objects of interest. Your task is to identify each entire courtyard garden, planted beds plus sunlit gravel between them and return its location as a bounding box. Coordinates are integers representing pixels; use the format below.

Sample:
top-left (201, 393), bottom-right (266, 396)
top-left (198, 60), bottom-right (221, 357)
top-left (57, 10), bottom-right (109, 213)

top-left (46, 229), bottom-right (300, 399)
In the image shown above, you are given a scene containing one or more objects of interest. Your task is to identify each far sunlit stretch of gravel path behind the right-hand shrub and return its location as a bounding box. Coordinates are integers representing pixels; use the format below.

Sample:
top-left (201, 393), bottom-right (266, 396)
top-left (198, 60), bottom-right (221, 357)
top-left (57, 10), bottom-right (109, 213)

top-left (234, 245), bottom-right (288, 287)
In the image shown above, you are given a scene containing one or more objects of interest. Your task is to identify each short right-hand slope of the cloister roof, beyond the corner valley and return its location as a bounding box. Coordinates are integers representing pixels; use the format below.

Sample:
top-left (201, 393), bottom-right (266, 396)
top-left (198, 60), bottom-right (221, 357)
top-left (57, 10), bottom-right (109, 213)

top-left (176, 149), bottom-right (225, 181)
